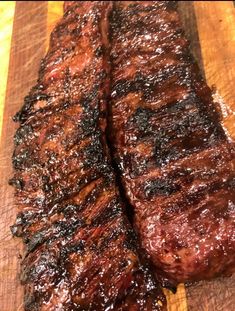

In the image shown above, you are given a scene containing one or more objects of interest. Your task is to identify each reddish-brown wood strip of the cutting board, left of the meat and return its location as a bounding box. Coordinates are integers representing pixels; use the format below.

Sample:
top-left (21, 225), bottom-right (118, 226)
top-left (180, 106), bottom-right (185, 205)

top-left (0, 1), bottom-right (47, 311)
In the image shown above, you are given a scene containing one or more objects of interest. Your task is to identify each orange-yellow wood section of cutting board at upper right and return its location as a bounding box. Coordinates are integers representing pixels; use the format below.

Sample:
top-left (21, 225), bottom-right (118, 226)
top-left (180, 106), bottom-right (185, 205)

top-left (194, 1), bottom-right (235, 139)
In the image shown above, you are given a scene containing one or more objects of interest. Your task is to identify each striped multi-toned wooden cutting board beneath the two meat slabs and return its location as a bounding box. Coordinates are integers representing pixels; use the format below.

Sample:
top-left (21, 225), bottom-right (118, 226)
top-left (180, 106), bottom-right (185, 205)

top-left (0, 1), bottom-right (235, 311)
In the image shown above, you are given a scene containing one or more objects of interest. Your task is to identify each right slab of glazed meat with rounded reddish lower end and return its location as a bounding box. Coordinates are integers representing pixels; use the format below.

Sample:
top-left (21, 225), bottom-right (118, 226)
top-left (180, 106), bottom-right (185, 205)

top-left (110, 1), bottom-right (235, 285)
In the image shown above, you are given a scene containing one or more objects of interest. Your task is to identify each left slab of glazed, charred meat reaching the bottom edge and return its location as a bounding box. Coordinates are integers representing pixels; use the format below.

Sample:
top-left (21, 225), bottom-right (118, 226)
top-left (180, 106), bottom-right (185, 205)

top-left (11, 1), bottom-right (166, 311)
